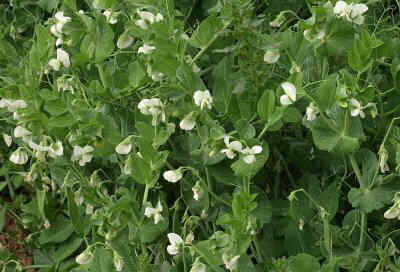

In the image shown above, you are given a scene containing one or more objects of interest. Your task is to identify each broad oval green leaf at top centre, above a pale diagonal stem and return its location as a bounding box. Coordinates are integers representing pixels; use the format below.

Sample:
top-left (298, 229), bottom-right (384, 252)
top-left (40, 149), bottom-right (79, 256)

top-left (189, 15), bottom-right (223, 48)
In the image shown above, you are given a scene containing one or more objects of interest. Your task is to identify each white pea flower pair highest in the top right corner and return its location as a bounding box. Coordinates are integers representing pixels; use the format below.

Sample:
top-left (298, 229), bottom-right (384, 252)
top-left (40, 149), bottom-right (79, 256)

top-left (333, 1), bottom-right (368, 25)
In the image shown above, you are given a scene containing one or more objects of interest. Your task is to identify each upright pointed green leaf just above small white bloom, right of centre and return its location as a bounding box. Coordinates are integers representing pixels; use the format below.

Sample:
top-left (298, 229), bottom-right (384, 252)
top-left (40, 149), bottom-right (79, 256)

top-left (312, 74), bottom-right (337, 111)
